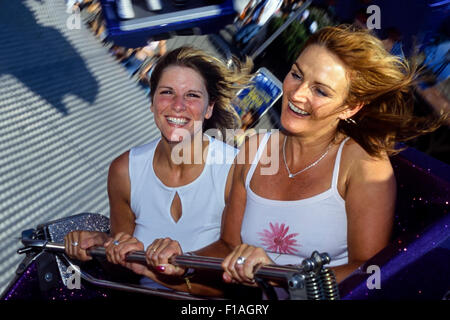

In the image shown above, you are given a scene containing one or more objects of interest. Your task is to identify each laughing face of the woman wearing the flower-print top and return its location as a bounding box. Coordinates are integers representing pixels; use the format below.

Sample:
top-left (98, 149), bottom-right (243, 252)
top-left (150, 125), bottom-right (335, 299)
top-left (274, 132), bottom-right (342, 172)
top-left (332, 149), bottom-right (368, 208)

top-left (281, 45), bottom-right (349, 134)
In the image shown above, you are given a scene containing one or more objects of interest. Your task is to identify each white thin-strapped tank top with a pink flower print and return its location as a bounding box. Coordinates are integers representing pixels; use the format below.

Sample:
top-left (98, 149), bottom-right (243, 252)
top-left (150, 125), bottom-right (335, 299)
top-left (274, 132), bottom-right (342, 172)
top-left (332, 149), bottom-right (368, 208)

top-left (241, 133), bottom-right (349, 266)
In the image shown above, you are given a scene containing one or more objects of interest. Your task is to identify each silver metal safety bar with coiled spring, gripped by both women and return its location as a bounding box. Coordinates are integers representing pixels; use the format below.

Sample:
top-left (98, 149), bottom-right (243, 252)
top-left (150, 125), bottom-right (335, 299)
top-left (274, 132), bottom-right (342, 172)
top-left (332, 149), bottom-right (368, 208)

top-left (18, 229), bottom-right (339, 300)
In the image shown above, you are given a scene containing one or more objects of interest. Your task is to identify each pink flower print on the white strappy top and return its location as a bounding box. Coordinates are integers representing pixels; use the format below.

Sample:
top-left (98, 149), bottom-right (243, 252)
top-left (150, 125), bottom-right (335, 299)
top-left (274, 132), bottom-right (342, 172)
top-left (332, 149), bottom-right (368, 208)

top-left (258, 222), bottom-right (300, 254)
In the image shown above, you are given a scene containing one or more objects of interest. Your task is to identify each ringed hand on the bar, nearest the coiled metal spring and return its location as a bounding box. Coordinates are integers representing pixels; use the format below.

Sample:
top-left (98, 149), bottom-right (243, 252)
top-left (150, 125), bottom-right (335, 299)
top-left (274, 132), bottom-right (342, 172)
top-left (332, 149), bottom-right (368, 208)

top-left (222, 244), bottom-right (274, 286)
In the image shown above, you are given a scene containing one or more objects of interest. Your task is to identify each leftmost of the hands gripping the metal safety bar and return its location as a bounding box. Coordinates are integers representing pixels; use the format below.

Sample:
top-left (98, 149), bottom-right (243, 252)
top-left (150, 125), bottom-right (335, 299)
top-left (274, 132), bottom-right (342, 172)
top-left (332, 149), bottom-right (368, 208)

top-left (64, 230), bottom-right (109, 261)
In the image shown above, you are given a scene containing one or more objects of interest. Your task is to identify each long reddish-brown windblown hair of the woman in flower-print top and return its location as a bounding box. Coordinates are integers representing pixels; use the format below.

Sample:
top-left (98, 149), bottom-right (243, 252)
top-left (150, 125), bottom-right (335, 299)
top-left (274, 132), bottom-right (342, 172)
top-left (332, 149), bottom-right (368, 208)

top-left (304, 25), bottom-right (442, 156)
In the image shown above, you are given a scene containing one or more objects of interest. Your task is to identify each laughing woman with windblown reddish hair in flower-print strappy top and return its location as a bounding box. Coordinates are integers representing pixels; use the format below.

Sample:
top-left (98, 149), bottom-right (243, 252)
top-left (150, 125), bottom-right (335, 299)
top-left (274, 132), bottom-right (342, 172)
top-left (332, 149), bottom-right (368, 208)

top-left (147, 26), bottom-right (446, 298)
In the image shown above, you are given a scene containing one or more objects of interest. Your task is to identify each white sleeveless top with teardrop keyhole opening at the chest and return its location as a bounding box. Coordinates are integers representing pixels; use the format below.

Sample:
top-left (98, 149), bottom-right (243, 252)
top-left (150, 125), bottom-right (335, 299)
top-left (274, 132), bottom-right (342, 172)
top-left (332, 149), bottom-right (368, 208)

top-left (129, 137), bottom-right (237, 252)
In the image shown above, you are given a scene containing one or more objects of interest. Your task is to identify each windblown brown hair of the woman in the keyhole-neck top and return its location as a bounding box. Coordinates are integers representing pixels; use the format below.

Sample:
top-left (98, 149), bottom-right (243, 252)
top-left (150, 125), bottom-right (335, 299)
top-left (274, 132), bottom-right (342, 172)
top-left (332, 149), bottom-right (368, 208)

top-left (150, 46), bottom-right (253, 136)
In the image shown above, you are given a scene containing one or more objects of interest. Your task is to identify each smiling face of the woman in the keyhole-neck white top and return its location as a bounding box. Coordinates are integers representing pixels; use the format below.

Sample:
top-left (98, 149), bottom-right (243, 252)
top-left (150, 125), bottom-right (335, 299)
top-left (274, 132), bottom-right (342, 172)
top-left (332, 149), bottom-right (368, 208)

top-left (151, 66), bottom-right (213, 142)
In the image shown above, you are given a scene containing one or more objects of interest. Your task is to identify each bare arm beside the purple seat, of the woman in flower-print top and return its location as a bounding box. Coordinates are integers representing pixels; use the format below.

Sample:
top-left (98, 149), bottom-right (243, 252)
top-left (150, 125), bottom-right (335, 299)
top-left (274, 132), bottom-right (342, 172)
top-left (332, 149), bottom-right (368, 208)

top-left (332, 149), bottom-right (396, 282)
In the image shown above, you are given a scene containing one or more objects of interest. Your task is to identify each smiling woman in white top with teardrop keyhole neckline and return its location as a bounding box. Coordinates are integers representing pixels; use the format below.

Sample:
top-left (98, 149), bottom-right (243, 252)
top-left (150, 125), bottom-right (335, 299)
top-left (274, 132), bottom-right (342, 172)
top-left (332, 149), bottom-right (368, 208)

top-left (65, 47), bottom-right (251, 296)
